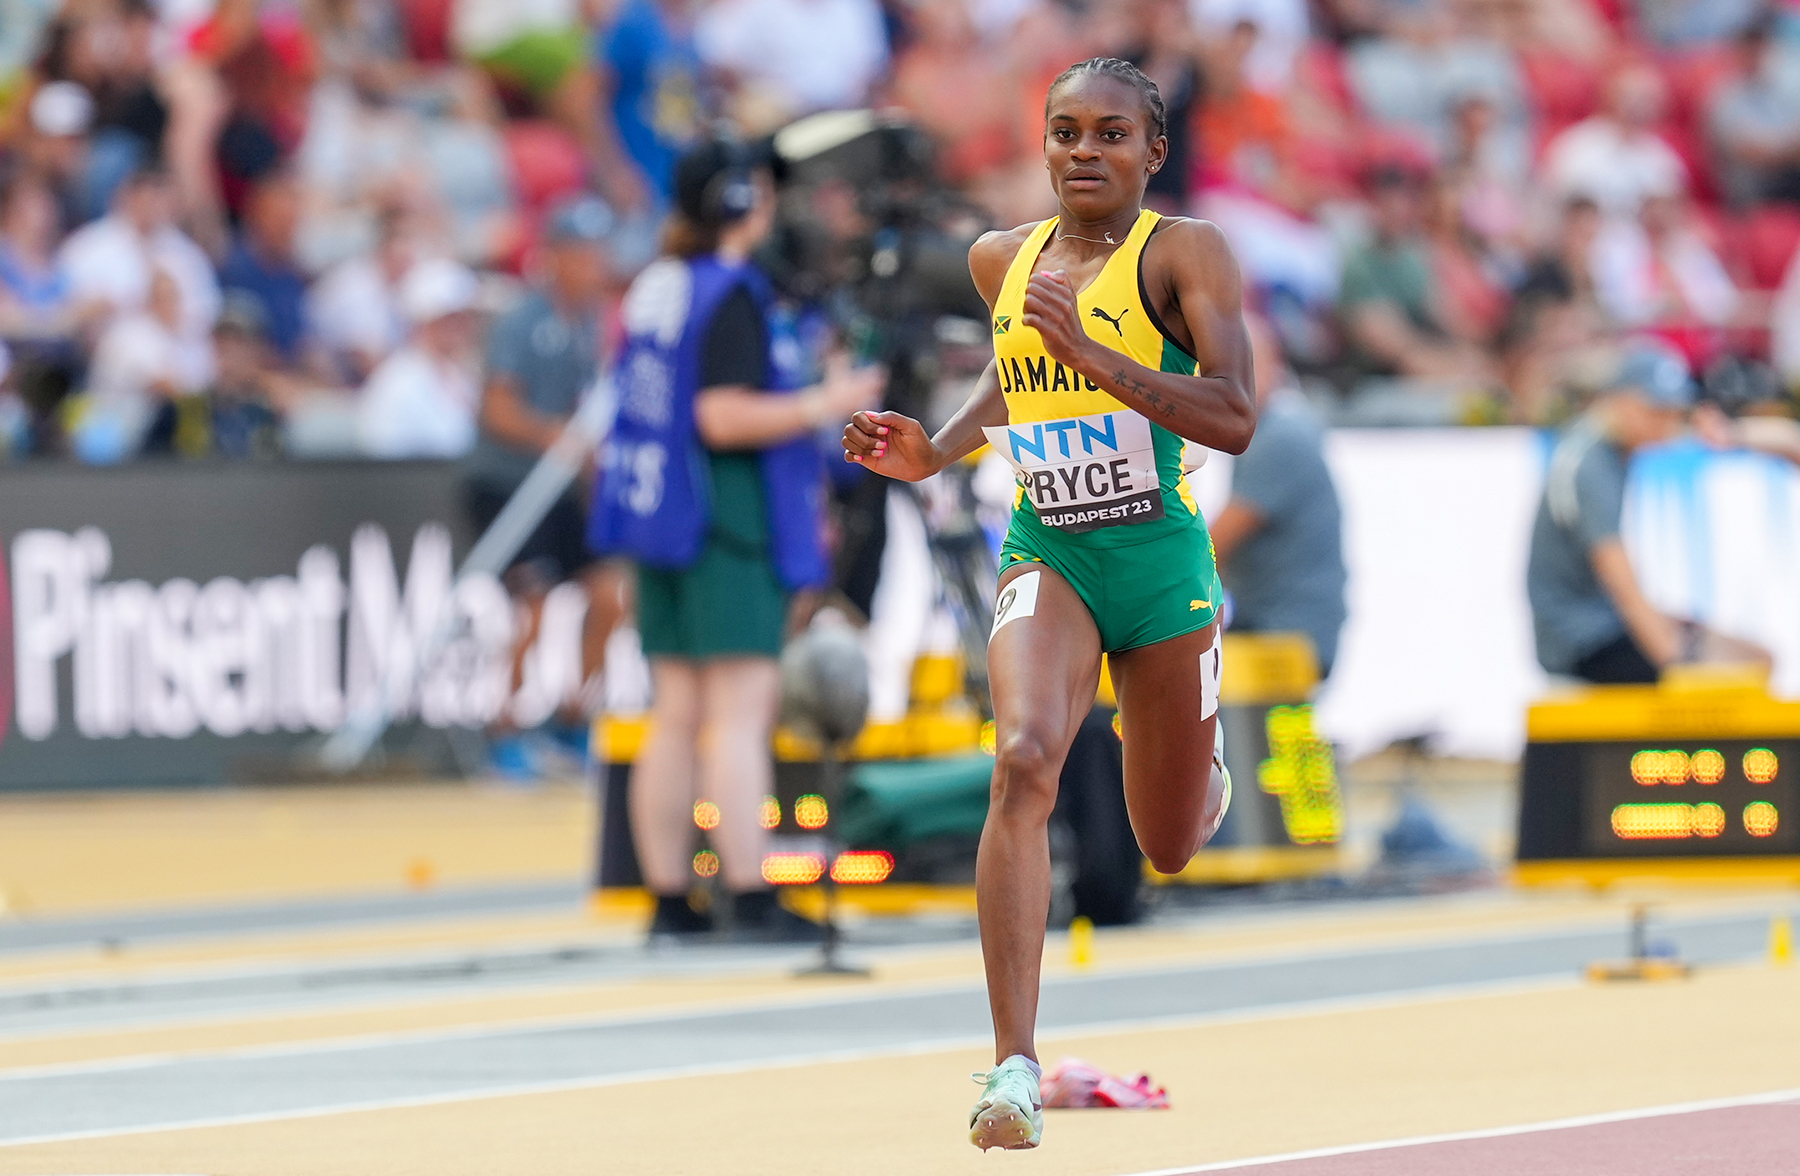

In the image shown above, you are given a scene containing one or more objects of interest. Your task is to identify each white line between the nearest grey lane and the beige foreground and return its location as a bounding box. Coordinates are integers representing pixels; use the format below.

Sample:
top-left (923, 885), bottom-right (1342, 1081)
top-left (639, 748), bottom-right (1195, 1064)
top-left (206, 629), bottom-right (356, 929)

top-left (0, 974), bottom-right (1582, 1145)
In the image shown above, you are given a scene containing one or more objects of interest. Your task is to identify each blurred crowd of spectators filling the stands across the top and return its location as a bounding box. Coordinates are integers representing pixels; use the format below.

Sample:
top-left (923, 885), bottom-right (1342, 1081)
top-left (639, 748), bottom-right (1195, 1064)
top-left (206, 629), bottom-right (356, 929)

top-left (0, 0), bottom-right (1800, 463)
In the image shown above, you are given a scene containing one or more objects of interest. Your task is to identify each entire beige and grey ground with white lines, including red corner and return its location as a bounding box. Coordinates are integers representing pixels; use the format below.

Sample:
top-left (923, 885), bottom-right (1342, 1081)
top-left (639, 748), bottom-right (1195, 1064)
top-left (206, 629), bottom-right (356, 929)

top-left (0, 777), bottom-right (1800, 1176)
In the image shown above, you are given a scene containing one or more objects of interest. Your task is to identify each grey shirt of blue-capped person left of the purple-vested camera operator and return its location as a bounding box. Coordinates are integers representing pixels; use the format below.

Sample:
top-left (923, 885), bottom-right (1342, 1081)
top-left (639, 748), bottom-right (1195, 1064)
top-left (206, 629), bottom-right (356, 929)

top-left (468, 290), bottom-right (599, 492)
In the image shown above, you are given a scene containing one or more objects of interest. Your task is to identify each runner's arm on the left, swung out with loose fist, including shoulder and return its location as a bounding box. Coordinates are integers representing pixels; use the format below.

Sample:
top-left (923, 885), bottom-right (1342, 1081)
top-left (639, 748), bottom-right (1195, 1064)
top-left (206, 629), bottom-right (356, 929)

top-left (844, 225), bottom-right (1031, 483)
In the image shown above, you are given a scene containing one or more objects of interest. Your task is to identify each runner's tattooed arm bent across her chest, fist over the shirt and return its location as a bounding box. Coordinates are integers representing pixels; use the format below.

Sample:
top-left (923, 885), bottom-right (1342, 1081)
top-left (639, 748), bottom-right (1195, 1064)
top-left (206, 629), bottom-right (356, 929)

top-left (1022, 220), bottom-right (1256, 454)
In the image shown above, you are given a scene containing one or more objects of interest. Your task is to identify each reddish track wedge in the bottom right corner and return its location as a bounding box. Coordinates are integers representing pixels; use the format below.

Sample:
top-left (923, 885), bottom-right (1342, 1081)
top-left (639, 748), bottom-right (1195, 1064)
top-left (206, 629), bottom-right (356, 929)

top-left (1157, 1100), bottom-right (1800, 1176)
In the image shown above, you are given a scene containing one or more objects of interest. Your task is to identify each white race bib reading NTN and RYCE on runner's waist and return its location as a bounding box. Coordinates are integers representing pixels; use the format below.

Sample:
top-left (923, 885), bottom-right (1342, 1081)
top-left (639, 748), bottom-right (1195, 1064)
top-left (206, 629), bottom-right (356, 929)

top-left (981, 411), bottom-right (1163, 531)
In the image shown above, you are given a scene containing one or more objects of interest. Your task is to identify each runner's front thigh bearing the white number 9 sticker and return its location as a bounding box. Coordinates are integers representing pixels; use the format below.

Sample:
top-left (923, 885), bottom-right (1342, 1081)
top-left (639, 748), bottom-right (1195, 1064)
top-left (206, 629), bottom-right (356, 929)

top-left (988, 564), bottom-right (1100, 760)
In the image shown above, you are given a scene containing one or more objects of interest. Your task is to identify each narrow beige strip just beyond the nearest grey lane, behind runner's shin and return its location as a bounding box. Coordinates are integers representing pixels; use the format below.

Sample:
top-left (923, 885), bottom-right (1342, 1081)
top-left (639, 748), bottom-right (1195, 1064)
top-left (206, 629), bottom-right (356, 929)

top-left (0, 895), bottom-right (1792, 1073)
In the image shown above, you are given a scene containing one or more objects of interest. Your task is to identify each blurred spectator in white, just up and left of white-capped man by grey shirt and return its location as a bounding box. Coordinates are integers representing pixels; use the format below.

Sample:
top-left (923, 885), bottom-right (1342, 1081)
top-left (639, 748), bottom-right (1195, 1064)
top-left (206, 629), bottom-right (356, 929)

top-left (306, 209), bottom-right (421, 384)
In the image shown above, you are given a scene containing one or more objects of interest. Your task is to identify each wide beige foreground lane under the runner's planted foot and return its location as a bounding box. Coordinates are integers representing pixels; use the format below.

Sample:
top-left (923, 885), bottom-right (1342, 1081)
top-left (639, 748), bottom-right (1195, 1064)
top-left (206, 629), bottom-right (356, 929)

top-left (0, 965), bottom-right (1800, 1176)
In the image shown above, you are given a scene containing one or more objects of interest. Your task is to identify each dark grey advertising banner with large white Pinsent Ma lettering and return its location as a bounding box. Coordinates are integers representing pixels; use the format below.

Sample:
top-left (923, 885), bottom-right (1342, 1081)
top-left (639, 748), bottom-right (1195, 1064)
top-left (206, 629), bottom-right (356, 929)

top-left (0, 463), bottom-right (585, 789)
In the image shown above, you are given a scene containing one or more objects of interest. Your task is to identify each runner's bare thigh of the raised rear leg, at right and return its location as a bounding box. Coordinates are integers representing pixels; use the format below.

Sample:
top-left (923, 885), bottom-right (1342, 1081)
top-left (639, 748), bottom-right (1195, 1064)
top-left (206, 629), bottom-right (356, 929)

top-left (1109, 621), bottom-right (1219, 839)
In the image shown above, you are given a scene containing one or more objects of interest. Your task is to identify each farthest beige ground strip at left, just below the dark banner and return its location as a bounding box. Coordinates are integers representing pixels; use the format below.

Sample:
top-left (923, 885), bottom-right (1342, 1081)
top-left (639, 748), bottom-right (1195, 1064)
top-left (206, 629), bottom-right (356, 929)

top-left (0, 783), bottom-right (596, 917)
